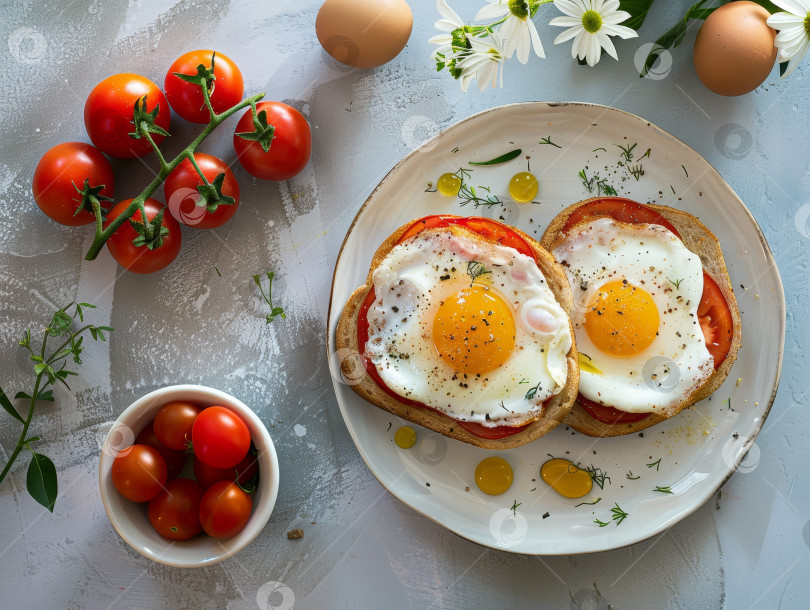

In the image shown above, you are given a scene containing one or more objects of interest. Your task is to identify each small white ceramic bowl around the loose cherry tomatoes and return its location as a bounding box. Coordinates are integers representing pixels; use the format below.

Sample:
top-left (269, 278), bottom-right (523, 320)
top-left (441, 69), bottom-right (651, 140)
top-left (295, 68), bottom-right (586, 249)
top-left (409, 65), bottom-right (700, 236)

top-left (99, 385), bottom-right (278, 568)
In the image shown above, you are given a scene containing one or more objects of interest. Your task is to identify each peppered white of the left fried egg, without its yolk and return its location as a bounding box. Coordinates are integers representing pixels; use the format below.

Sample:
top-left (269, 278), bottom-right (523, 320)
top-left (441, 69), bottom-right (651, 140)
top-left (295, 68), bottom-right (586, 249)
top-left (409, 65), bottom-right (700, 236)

top-left (366, 229), bottom-right (572, 427)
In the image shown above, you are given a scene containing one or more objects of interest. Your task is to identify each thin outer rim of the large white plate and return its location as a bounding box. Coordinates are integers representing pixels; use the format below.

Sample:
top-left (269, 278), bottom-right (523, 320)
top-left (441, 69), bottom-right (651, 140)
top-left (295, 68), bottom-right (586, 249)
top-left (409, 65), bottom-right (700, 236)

top-left (326, 100), bottom-right (787, 556)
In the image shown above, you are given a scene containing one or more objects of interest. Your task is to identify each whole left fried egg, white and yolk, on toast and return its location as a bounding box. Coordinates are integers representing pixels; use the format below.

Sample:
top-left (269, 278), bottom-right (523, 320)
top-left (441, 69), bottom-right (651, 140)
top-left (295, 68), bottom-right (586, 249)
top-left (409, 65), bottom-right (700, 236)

top-left (366, 229), bottom-right (572, 427)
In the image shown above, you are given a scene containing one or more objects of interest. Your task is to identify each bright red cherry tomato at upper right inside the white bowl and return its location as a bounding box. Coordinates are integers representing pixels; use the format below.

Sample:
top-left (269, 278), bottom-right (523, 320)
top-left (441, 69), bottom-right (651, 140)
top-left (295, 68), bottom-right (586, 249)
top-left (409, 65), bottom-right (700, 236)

top-left (191, 407), bottom-right (250, 468)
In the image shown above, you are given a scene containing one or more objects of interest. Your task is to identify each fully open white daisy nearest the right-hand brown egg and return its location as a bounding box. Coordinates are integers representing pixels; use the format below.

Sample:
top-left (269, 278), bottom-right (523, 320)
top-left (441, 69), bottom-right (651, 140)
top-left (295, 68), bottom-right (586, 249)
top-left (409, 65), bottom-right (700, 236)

top-left (549, 0), bottom-right (636, 67)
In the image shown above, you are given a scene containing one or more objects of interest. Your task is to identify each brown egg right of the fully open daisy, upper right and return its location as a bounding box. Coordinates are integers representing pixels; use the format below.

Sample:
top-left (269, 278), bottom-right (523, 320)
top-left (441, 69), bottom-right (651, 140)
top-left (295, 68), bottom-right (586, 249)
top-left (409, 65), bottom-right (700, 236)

top-left (695, 1), bottom-right (777, 95)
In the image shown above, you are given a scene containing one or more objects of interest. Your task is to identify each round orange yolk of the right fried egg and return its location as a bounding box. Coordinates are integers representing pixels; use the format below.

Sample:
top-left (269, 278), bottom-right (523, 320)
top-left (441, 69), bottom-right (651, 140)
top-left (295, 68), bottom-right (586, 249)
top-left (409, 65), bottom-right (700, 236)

top-left (584, 280), bottom-right (659, 358)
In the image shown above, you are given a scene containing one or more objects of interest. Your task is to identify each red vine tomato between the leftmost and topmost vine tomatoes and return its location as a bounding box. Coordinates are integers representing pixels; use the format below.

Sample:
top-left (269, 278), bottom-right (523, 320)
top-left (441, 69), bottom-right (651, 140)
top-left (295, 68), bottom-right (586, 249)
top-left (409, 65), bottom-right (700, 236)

top-left (84, 73), bottom-right (171, 159)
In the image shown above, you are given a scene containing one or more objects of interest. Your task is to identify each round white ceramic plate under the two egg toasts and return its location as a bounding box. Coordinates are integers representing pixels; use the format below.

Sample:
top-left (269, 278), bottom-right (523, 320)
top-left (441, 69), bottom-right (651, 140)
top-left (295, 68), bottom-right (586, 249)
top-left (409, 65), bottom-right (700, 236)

top-left (328, 102), bottom-right (785, 554)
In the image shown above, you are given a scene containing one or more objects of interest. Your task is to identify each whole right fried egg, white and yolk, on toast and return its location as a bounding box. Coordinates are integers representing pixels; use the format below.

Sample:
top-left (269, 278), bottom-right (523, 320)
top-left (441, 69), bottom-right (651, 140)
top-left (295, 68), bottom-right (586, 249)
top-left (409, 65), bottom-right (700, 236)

top-left (553, 218), bottom-right (714, 416)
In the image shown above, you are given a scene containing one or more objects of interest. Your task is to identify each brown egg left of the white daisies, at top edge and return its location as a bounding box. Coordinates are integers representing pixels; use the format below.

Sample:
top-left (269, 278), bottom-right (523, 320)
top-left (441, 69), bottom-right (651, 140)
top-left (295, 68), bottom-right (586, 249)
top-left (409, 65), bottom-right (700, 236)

top-left (315, 0), bottom-right (413, 68)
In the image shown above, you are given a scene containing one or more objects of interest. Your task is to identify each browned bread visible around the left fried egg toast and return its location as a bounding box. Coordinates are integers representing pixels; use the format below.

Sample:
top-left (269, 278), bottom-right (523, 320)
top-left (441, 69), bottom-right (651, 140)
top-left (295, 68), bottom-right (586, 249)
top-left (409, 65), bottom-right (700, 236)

top-left (335, 217), bottom-right (579, 449)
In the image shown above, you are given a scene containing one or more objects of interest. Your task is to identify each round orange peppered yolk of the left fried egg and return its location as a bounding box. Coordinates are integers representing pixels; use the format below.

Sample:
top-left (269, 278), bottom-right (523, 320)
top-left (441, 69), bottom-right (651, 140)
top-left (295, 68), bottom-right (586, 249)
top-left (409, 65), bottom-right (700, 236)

top-left (433, 284), bottom-right (515, 375)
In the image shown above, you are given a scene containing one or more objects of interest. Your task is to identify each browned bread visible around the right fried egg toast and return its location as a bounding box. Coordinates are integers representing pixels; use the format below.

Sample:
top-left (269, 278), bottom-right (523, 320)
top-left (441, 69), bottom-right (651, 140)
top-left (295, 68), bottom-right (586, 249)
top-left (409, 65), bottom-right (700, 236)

top-left (540, 197), bottom-right (741, 436)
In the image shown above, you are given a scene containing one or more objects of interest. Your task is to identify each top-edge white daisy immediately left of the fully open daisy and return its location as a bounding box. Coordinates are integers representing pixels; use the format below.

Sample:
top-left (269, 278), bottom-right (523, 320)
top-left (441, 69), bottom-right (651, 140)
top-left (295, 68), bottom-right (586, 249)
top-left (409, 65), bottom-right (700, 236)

top-left (475, 0), bottom-right (546, 64)
